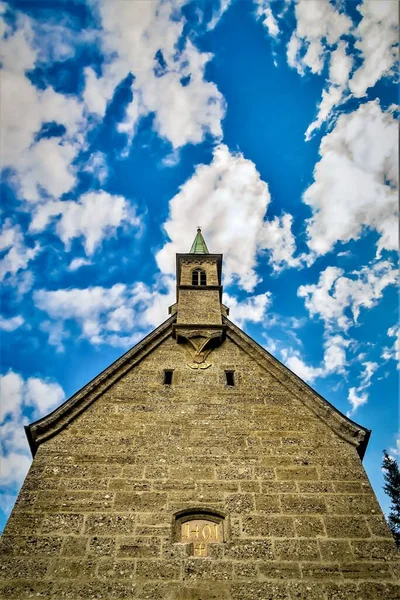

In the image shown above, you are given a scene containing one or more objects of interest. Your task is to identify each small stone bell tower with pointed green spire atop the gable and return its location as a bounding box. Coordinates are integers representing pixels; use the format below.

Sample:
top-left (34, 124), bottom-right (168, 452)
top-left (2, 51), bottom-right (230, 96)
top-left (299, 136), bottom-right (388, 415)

top-left (170, 227), bottom-right (228, 369)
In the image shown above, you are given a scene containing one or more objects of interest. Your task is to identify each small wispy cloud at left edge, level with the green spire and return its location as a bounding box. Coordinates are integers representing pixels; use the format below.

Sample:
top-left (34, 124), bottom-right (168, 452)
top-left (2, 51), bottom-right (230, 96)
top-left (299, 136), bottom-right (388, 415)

top-left (0, 219), bottom-right (41, 285)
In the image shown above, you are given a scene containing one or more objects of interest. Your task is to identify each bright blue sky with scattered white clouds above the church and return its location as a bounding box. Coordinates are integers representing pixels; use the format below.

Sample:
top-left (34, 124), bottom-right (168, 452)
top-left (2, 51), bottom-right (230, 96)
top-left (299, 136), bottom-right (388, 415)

top-left (0, 0), bottom-right (399, 536)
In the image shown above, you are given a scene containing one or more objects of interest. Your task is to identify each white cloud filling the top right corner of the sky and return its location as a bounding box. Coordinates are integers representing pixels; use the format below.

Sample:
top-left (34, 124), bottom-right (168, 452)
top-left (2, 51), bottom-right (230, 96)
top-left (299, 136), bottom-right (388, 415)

top-left (350, 0), bottom-right (399, 97)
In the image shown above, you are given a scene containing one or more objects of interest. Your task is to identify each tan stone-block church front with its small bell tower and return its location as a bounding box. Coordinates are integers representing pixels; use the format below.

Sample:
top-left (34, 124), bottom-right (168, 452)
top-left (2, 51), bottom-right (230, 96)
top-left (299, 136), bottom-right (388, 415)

top-left (0, 231), bottom-right (399, 600)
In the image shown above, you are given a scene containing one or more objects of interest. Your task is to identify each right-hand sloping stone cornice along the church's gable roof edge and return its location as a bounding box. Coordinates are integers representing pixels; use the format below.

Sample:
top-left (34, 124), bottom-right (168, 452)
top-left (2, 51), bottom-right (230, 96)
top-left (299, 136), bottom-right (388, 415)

top-left (223, 317), bottom-right (371, 459)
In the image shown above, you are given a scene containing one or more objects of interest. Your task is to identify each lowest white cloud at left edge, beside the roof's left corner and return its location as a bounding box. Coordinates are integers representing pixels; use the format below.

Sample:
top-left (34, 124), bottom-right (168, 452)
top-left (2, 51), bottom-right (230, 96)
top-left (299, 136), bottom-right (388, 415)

top-left (0, 371), bottom-right (65, 492)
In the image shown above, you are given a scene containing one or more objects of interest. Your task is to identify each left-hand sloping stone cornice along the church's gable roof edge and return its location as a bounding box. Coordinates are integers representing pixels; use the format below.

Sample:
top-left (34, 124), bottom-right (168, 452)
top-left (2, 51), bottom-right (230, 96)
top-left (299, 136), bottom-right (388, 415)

top-left (25, 315), bottom-right (176, 456)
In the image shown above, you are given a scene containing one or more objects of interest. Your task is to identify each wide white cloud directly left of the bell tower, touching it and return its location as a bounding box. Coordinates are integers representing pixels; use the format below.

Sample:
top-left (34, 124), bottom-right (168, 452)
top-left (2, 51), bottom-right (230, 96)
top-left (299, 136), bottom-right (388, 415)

top-left (34, 276), bottom-right (175, 350)
